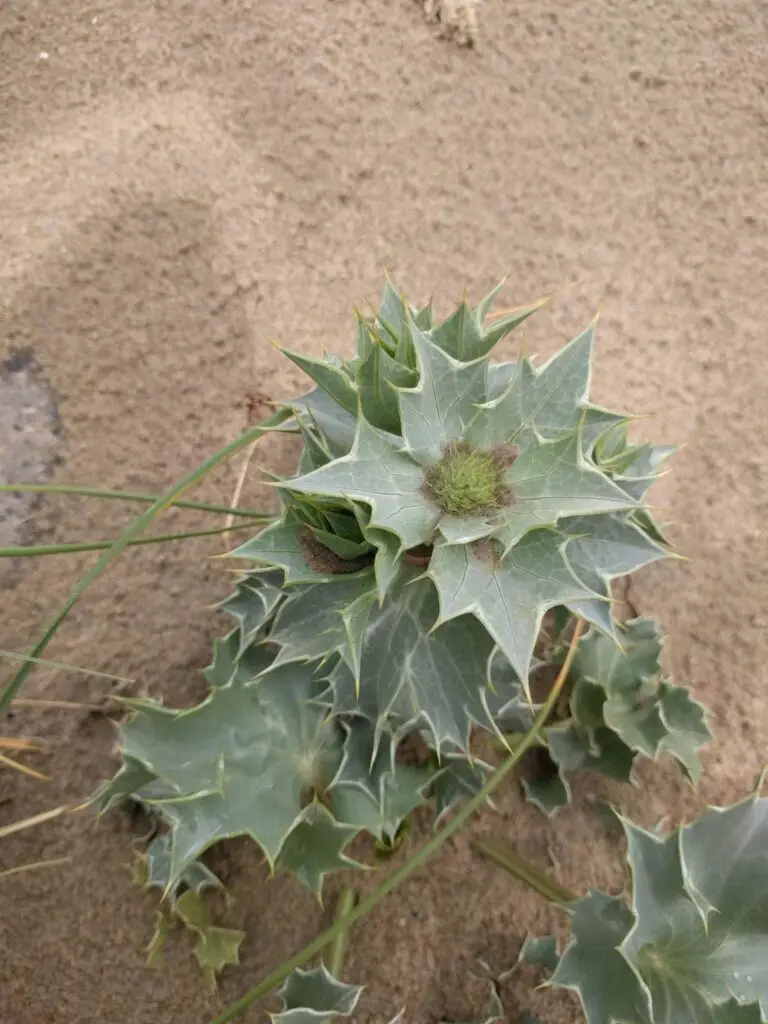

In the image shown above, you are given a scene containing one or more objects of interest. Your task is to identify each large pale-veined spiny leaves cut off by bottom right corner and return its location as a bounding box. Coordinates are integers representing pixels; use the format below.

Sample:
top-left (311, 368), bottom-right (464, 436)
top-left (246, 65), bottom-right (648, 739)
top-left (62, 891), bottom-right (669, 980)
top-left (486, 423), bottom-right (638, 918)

top-left (521, 793), bottom-right (768, 1024)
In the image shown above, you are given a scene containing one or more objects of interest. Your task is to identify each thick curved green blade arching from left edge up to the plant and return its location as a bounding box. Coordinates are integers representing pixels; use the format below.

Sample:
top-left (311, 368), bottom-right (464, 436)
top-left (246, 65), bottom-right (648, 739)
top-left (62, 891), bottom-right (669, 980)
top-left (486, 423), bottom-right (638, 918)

top-left (0, 409), bottom-right (293, 715)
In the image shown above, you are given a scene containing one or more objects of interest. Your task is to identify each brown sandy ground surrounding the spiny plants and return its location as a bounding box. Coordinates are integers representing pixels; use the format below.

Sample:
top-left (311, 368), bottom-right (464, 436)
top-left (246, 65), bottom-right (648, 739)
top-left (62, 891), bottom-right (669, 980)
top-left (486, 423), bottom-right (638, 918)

top-left (0, 0), bottom-right (768, 1024)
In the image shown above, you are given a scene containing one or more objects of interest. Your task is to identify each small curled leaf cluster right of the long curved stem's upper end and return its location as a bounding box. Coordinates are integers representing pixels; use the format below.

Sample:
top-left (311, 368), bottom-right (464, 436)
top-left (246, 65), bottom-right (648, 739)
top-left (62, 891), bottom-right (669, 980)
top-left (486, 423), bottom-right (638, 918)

top-left (523, 618), bottom-right (712, 815)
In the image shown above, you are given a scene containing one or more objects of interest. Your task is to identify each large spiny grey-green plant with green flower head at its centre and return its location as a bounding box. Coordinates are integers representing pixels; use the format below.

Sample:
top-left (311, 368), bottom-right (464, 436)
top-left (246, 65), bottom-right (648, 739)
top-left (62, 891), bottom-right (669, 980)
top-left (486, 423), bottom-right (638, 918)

top-left (98, 285), bottom-right (670, 894)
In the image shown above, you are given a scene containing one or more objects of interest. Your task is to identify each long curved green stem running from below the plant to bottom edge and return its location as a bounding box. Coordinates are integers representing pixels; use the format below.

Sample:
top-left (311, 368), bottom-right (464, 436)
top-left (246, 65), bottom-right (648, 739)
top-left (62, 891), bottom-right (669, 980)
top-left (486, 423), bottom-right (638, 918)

top-left (209, 621), bottom-right (585, 1024)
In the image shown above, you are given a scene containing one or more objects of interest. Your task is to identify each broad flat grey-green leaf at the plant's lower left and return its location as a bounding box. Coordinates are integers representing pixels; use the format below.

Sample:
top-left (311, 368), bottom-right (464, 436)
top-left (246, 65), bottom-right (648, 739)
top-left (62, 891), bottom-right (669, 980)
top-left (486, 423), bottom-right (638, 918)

top-left (101, 664), bottom-right (342, 881)
